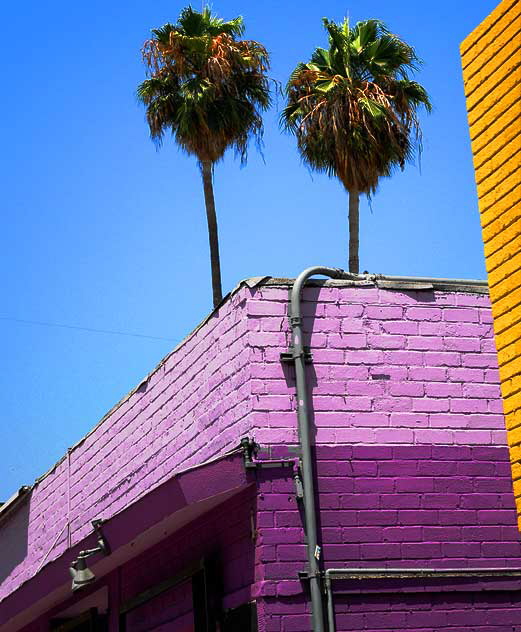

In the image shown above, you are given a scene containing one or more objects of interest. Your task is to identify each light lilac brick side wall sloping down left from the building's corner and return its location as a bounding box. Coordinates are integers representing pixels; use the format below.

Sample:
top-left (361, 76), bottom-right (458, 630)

top-left (0, 289), bottom-right (250, 600)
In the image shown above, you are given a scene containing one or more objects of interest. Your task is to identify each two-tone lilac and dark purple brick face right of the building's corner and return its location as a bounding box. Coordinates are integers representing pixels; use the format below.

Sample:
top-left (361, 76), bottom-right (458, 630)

top-left (249, 286), bottom-right (521, 632)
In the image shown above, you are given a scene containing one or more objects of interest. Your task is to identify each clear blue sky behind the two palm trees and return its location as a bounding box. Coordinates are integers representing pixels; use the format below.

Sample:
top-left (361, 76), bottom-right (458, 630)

top-left (0, 0), bottom-right (497, 500)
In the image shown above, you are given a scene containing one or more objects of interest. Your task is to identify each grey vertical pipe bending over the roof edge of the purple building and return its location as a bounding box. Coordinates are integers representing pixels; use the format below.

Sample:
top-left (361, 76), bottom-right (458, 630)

top-left (289, 266), bottom-right (350, 632)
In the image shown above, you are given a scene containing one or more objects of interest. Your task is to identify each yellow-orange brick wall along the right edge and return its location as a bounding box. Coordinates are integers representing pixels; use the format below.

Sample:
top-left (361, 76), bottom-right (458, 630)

top-left (461, 0), bottom-right (521, 530)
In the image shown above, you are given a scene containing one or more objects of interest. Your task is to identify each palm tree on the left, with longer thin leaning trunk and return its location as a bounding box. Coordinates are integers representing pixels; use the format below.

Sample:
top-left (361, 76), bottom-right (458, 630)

top-left (137, 6), bottom-right (271, 307)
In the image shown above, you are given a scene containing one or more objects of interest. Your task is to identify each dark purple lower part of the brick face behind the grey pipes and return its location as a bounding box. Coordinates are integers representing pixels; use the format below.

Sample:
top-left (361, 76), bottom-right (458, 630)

top-left (256, 445), bottom-right (521, 632)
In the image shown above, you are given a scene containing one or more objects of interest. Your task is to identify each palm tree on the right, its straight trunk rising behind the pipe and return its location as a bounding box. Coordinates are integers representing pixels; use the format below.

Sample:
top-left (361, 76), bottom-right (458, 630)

top-left (281, 18), bottom-right (431, 274)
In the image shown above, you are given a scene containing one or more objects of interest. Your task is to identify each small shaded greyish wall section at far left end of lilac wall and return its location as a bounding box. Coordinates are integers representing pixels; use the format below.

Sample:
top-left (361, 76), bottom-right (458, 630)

top-left (0, 499), bottom-right (30, 584)
